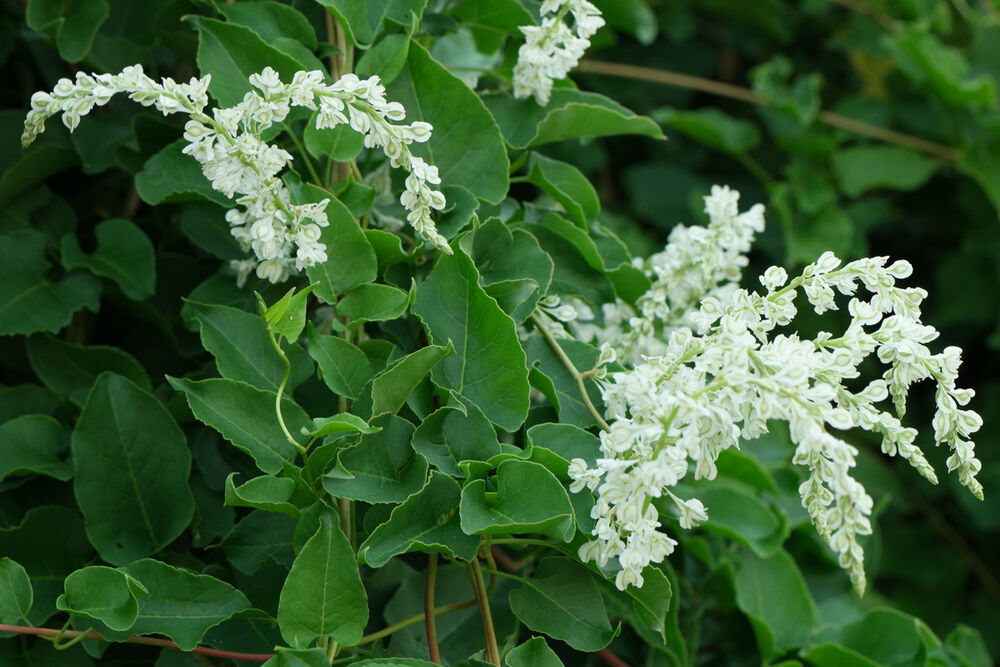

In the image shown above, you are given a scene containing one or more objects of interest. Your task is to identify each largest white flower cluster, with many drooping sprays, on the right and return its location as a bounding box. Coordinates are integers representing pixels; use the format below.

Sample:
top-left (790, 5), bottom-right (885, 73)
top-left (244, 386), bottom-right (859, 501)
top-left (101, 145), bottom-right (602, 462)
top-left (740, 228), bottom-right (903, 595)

top-left (570, 185), bottom-right (982, 591)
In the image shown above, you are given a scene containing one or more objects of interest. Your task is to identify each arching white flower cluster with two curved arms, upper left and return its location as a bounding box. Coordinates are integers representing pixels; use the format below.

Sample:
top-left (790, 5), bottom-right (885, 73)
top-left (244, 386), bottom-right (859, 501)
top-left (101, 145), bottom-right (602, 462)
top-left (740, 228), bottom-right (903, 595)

top-left (21, 65), bottom-right (451, 283)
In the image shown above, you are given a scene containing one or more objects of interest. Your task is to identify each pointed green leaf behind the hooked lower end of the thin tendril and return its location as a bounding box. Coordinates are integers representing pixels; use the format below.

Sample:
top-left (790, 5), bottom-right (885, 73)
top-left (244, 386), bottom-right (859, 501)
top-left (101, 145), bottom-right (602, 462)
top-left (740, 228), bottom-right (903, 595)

top-left (167, 376), bottom-right (312, 475)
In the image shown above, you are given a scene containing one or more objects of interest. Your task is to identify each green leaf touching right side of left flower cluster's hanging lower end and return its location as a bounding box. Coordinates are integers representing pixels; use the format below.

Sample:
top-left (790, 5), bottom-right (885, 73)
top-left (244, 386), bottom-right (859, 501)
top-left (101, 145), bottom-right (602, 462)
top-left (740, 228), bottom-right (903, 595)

top-left (306, 193), bottom-right (378, 304)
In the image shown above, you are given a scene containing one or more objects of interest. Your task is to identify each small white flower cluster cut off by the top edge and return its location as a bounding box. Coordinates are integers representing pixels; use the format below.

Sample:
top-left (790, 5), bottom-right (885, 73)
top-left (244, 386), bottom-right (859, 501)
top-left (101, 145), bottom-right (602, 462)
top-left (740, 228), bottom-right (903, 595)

top-left (514, 0), bottom-right (604, 106)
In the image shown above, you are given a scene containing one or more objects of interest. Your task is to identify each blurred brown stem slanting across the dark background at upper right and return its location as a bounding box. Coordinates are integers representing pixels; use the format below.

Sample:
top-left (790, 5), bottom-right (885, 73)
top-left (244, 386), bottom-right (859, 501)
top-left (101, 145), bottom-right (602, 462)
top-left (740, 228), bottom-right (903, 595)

top-left (577, 60), bottom-right (961, 162)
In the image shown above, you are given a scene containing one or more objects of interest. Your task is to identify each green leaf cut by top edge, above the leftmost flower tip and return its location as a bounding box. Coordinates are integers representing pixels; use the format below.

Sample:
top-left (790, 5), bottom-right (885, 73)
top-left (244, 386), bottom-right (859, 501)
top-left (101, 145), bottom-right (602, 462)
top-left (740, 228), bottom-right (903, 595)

top-left (24, 0), bottom-right (111, 63)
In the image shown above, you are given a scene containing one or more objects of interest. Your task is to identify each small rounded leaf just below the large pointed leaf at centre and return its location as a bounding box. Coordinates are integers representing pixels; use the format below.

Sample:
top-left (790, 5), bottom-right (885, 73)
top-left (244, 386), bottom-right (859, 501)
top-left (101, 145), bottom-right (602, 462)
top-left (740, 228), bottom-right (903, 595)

top-left (413, 401), bottom-right (500, 477)
